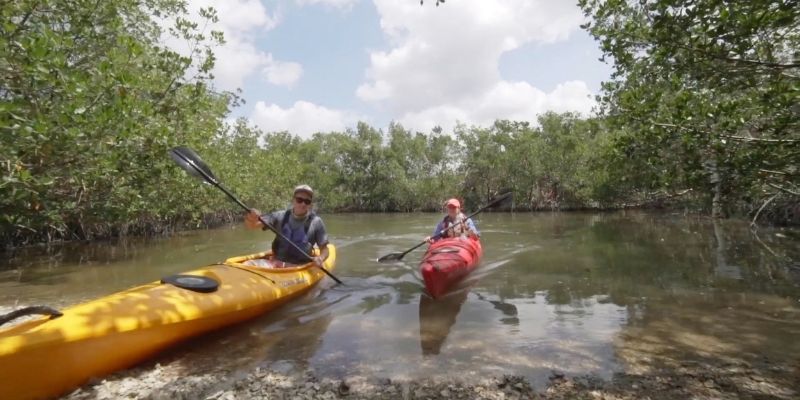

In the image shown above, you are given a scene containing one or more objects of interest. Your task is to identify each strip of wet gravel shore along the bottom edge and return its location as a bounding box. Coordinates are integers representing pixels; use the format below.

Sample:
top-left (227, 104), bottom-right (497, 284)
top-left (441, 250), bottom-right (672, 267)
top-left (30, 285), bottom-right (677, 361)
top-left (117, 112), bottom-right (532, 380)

top-left (64, 360), bottom-right (800, 400)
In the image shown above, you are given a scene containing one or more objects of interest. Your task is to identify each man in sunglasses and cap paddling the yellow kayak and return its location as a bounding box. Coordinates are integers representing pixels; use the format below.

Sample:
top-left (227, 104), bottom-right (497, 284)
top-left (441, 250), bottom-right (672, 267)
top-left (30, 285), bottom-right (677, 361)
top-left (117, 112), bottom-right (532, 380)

top-left (244, 185), bottom-right (328, 268)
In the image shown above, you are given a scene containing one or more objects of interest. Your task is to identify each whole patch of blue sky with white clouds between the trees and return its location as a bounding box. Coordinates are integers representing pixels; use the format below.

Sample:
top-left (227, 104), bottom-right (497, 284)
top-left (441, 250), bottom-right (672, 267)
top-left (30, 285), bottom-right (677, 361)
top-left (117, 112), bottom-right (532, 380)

top-left (183, 0), bottom-right (611, 137)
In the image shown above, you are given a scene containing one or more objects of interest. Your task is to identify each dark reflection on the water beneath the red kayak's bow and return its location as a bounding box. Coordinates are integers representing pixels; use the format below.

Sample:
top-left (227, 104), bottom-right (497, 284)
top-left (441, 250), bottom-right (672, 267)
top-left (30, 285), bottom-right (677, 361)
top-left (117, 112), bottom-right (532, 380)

top-left (419, 288), bottom-right (469, 355)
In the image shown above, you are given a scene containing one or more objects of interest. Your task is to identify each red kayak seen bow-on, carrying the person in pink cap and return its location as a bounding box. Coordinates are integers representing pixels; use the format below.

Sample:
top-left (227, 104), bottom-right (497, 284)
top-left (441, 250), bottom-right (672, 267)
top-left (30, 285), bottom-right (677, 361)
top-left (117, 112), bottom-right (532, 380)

top-left (419, 238), bottom-right (483, 298)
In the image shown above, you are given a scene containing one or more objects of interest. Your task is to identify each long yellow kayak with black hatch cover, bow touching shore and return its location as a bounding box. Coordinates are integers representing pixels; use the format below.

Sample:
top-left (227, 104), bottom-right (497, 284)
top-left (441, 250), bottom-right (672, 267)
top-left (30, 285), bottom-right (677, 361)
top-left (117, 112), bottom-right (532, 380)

top-left (0, 245), bottom-right (336, 399)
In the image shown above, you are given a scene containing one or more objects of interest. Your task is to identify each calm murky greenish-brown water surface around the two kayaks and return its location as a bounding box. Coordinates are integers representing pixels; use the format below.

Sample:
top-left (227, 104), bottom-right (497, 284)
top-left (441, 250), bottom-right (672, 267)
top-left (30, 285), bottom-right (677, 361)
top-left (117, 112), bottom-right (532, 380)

top-left (0, 212), bottom-right (800, 384)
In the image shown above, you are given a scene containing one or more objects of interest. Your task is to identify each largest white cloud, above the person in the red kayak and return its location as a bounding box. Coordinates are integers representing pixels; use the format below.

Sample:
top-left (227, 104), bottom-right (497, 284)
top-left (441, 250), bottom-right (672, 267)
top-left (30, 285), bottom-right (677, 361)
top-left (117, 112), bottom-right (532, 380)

top-left (356, 0), bottom-right (594, 130)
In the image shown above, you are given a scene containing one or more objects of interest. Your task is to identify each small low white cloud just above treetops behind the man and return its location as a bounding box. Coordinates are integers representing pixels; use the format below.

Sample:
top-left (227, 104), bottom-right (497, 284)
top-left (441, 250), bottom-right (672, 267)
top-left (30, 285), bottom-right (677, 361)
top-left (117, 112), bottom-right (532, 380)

top-left (250, 101), bottom-right (363, 138)
